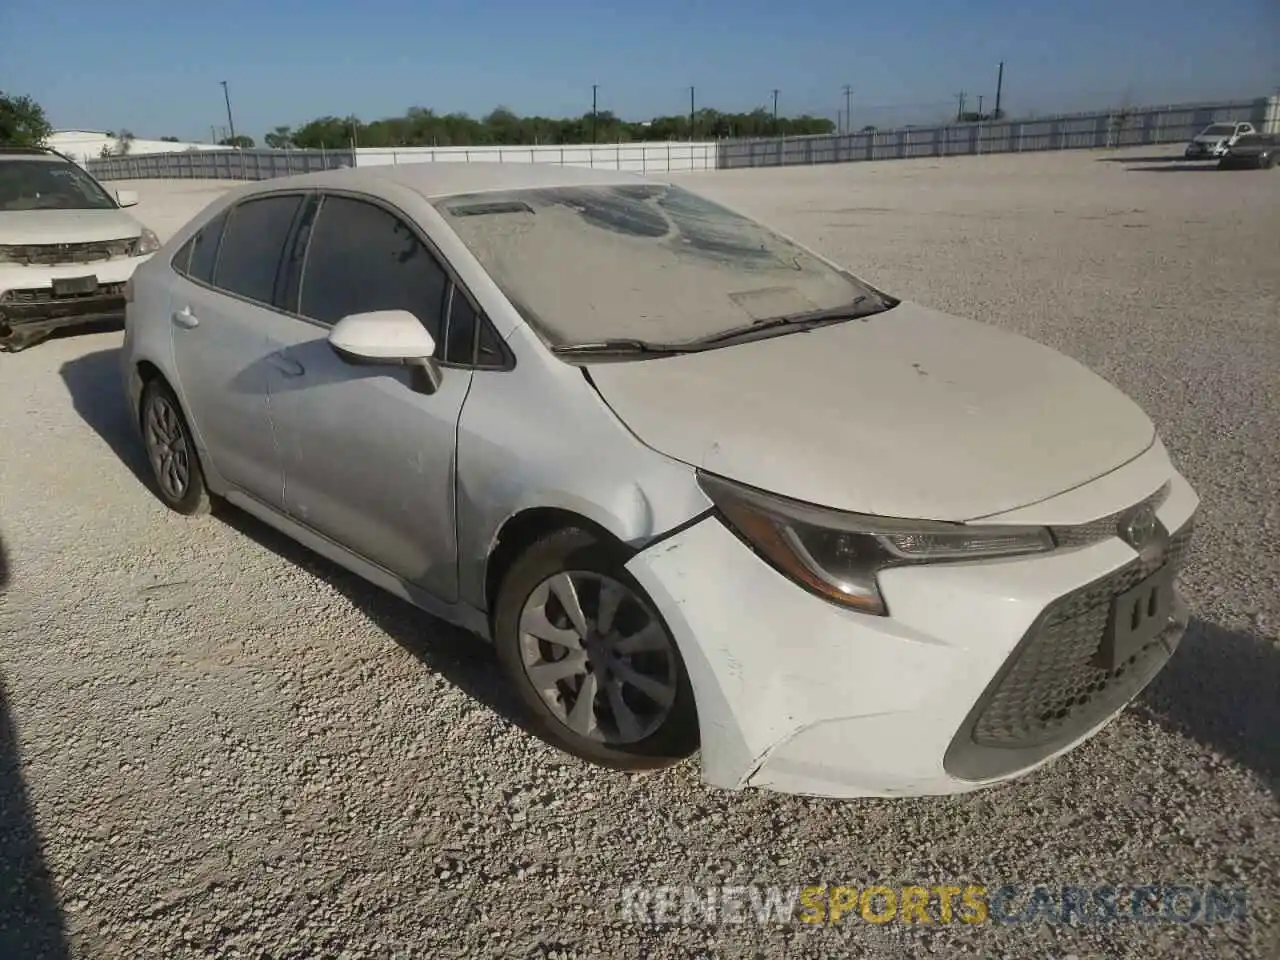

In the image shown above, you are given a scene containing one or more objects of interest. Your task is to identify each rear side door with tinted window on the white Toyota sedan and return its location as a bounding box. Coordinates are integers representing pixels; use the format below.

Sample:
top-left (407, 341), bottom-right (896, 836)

top-left (170, 192), bottom-right (303, 508)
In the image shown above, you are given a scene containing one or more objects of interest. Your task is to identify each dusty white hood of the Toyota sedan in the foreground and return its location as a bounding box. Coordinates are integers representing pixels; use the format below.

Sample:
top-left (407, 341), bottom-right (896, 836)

top-left (589, 302), bottom-right (1156, 521)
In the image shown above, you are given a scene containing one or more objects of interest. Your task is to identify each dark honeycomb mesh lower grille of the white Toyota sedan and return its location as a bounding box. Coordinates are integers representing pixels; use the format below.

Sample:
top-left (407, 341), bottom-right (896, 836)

top-left (972, 521), bottom-right (1192, 749)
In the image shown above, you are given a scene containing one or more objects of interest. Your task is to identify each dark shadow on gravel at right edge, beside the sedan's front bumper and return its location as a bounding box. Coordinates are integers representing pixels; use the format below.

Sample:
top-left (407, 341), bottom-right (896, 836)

top-left (1137, 618), bottom-right (1280, 795)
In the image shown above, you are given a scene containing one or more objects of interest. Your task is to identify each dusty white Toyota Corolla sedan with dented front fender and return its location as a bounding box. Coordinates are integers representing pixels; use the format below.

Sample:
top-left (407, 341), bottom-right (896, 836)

top-left (123, 164), bottom-right (1198, 796)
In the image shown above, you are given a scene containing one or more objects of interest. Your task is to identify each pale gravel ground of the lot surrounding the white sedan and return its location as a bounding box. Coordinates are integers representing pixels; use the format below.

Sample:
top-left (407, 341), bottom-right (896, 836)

top-left (0, 150), bottom-right (1280, 960)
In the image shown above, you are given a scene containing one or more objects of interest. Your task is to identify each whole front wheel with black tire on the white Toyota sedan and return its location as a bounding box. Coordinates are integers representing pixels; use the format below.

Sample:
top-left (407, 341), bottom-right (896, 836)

top-left (494, 527), bottom-right (699, 771)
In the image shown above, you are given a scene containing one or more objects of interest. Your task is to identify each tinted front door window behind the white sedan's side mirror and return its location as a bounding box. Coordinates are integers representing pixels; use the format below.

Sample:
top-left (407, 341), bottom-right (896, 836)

top-left (298, 197), bottom-right (448, 343)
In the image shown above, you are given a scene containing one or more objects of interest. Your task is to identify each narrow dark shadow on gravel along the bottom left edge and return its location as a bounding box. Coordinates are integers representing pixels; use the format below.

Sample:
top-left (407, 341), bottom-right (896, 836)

top-left (0, 543), bottom-right (70, 960)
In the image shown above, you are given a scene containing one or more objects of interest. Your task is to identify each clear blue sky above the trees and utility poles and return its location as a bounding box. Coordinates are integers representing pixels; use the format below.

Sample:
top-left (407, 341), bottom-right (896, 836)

top-left (0, 0), bottom-right (1280, 140)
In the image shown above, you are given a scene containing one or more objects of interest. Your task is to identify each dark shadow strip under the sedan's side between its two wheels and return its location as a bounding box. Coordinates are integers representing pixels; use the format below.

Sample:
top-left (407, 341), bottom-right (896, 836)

top-left (214, 512), bottom-right (538, 736)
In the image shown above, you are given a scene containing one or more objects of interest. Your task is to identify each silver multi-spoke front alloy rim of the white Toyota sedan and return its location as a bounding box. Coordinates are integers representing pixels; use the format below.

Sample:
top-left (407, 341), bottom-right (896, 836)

top-left (518, 570), bottom-right (680, 744)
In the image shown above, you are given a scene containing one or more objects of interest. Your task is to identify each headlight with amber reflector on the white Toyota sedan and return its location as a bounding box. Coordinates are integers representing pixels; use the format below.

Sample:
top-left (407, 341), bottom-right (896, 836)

top-left (698, 472), bottom-right (1053, 616)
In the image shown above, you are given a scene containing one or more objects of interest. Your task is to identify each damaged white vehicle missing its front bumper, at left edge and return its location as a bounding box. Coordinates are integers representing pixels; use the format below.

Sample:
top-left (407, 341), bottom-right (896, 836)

top-left (0, 147), bottom-right (160, 351)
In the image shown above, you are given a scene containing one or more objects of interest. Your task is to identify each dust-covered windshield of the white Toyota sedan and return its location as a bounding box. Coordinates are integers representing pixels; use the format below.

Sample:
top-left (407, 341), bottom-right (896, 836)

top-left (436, 184), bottom-right (868, 346)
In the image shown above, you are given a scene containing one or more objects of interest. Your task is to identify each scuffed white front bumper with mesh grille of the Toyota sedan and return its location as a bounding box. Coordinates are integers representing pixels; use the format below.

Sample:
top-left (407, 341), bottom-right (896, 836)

top-left (627, 475), bottom-right (1198, 797)
